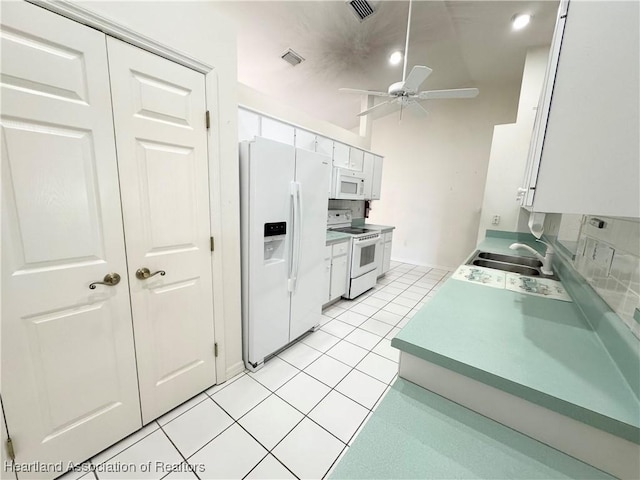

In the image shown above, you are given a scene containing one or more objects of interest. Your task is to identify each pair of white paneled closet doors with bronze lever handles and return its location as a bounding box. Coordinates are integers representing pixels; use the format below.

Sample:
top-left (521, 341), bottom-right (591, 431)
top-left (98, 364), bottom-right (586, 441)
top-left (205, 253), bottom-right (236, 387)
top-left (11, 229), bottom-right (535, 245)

top-left (0, 2), bottom-right (215, 478)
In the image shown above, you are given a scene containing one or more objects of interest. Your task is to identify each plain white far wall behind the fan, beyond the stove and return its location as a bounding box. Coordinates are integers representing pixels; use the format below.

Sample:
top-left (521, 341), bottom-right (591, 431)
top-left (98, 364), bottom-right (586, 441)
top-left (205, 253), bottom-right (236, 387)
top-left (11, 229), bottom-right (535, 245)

top-left (369, 85), bottom-right (518, 268)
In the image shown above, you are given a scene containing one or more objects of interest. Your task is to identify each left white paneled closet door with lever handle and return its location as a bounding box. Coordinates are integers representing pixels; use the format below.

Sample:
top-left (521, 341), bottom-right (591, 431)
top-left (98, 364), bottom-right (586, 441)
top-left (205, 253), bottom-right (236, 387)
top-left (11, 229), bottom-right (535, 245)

top-left (0, 2), bottom-right (141, 472)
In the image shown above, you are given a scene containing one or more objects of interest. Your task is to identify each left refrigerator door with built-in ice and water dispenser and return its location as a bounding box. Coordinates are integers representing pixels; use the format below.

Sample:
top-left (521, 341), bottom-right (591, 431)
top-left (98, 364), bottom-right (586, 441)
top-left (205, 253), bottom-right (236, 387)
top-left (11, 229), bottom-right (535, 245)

top-left (241, 137), bottom-right (298, 365)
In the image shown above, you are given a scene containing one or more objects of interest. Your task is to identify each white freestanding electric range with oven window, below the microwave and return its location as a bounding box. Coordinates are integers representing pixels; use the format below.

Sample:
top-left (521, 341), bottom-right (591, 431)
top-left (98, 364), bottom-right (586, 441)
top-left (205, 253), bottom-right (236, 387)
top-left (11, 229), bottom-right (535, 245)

top-left (327, 210), bottom-right (384, 298)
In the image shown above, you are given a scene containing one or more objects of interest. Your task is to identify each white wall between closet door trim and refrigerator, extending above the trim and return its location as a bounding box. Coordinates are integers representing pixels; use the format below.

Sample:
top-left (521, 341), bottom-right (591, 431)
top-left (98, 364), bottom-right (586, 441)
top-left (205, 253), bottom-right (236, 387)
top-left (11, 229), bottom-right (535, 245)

top-left (76, 1), bottom-right (244, 381)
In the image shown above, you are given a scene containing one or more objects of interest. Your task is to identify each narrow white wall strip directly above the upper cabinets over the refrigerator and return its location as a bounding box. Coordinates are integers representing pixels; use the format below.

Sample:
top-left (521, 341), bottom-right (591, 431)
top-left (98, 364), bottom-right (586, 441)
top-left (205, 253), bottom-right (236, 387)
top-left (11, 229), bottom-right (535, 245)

top-left (238, 83), bottom-right (369, 150)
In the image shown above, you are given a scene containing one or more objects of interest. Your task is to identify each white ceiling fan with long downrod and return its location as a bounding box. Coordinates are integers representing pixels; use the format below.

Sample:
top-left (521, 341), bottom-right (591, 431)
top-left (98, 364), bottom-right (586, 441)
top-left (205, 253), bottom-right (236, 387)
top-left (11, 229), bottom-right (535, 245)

top-left (340, 0), bottom-right (480, 118)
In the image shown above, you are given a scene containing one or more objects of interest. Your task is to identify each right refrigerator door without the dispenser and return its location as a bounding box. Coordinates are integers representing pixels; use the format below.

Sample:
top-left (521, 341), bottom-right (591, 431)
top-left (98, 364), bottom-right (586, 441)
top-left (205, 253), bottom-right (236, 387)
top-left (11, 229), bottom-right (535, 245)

top-left (290, 149), bottom-right (331, 341)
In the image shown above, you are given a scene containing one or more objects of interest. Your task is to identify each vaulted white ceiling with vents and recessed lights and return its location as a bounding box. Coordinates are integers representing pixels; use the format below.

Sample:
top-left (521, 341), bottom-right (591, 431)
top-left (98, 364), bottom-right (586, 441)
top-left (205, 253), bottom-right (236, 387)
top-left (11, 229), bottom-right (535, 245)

top-left (215, 0), bottom-right (558, 128)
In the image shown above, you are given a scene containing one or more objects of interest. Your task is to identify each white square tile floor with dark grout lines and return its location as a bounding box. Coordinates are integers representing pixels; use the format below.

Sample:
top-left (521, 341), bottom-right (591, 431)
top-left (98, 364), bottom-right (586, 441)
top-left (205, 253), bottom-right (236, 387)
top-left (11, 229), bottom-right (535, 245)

top-left (64, 262), bottom-right (450, 480)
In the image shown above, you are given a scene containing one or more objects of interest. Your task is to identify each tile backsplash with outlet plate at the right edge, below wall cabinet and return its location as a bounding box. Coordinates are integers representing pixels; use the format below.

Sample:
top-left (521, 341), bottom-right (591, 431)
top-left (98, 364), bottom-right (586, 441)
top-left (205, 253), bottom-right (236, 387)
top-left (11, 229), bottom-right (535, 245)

top-left (573, 215), bottom-right (640, 339)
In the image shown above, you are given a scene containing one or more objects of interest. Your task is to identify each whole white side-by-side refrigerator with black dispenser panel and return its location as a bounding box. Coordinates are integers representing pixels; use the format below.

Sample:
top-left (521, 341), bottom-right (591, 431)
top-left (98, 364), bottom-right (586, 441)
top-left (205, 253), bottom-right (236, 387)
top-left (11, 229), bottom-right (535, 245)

top-left (240, 137), bottom-right (331, 371)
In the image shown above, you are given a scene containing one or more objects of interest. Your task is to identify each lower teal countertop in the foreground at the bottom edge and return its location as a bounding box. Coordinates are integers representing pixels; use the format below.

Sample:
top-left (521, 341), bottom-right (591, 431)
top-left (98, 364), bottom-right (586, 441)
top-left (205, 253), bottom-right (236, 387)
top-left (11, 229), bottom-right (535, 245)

top-left (331, 378), bottom-right (612, 479)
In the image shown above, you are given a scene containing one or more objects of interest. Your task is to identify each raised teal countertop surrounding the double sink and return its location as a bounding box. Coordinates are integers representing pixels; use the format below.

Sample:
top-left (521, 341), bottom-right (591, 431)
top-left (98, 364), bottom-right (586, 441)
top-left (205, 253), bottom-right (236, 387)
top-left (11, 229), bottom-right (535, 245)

top-left (392, 238), bottom-right (640, 443)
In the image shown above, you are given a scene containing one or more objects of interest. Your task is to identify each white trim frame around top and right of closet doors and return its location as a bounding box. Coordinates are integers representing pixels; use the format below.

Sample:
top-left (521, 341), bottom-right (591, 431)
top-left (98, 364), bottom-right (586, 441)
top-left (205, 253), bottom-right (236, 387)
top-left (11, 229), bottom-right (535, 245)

top-left (26, 0), bottom-right (235, 384)
